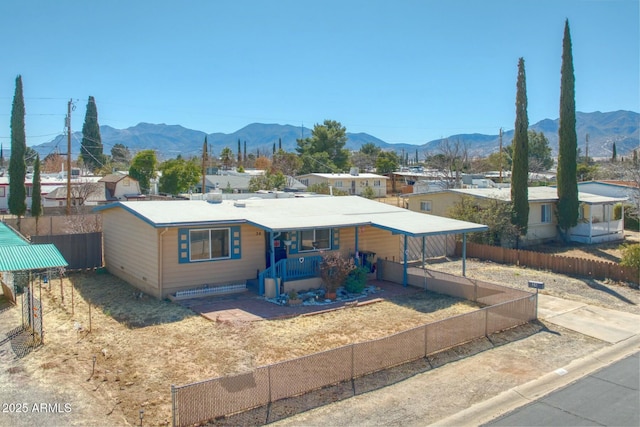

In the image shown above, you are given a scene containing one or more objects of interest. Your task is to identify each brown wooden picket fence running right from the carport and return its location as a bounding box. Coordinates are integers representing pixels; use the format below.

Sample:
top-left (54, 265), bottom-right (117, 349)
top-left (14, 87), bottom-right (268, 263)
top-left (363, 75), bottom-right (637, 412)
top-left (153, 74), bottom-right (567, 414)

top-left (456, 242), bottom-right (640, 283)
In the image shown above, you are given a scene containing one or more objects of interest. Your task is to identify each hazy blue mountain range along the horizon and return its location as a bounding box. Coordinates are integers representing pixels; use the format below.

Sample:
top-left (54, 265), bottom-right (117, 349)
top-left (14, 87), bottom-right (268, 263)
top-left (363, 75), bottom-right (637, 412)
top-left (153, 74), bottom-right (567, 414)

top-left (31, 110), bottom-right (640, 160)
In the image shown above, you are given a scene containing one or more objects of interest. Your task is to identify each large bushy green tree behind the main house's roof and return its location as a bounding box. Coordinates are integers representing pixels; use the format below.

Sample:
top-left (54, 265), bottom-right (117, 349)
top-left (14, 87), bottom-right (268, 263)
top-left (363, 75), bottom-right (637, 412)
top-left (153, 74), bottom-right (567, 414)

top-left (296, 120), bottom-right (349, 174)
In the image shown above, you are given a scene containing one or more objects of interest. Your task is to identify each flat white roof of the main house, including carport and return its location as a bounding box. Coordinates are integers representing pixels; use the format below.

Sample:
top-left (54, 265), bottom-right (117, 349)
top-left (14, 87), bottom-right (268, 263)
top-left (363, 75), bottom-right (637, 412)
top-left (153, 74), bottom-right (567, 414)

top-left (95, 196), bottom-right (487, 236)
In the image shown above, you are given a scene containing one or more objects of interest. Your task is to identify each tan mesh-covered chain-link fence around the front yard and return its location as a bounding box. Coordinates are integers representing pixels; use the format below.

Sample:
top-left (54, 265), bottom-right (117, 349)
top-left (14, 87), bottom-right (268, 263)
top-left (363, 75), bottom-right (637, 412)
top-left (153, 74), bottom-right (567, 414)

top-left (171, 260), bottom-right (537, 426)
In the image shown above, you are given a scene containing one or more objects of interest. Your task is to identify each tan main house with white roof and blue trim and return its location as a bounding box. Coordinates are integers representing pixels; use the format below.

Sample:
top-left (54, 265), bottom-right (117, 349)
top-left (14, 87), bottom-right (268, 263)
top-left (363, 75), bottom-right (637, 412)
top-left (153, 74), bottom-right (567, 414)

top-left (95, 195), bottom-right (487, 298)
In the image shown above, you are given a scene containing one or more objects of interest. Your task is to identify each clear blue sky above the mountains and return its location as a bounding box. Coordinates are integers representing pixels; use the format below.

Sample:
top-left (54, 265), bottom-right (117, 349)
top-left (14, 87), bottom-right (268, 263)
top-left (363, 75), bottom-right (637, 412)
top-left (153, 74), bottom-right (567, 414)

top-left (0, 0), bottom-right (640, 147)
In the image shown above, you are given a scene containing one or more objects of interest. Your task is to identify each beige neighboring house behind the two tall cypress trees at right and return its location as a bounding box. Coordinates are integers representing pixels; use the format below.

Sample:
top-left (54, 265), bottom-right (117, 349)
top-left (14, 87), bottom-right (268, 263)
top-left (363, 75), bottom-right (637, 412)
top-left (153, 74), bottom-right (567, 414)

top-left (405, 187), bottom-right (625, 246)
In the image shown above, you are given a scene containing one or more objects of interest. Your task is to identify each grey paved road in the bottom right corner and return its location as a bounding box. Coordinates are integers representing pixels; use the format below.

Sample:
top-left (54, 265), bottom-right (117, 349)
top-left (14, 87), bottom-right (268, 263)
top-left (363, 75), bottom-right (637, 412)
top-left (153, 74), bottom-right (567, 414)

top-left (484, 353), bottom-right (640, 426)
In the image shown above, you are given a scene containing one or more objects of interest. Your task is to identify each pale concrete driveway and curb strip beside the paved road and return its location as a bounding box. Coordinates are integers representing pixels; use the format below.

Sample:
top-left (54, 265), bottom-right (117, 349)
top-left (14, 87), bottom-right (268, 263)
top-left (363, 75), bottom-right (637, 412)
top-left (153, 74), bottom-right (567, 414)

top-left (431, 294), bottom-right (640, 426)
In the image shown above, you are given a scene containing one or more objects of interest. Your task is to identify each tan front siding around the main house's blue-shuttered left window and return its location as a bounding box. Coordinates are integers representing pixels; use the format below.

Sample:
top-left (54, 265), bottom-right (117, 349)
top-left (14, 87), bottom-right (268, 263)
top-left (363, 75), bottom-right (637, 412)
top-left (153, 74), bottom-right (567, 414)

top-left (162, 224), bottom-right (266, 296)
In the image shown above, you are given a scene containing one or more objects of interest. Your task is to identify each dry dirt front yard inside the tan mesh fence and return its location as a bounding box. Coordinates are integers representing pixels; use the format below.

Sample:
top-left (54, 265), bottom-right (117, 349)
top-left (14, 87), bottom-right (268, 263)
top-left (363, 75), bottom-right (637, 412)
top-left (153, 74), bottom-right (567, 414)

top-left (0, 273), bottom-right (477, 425)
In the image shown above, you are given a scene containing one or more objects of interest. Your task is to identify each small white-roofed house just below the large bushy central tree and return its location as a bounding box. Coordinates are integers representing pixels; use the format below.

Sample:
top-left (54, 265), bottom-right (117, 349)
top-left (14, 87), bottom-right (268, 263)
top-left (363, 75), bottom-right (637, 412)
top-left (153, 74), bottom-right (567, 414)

top-left (296, 168), bottom-right (388, 197)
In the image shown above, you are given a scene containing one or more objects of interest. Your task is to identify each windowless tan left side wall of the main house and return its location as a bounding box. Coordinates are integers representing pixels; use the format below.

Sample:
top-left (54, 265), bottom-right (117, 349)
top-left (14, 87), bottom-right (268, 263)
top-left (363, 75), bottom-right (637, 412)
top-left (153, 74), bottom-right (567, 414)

top-left (102, 209), bottom-right (160, 296)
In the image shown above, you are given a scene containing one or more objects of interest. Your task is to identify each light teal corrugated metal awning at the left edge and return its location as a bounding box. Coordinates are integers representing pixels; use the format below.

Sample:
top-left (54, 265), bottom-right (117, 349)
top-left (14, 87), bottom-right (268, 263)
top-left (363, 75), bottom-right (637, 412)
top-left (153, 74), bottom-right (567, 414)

top-left (0, 243), bottom-right (69, 271)
